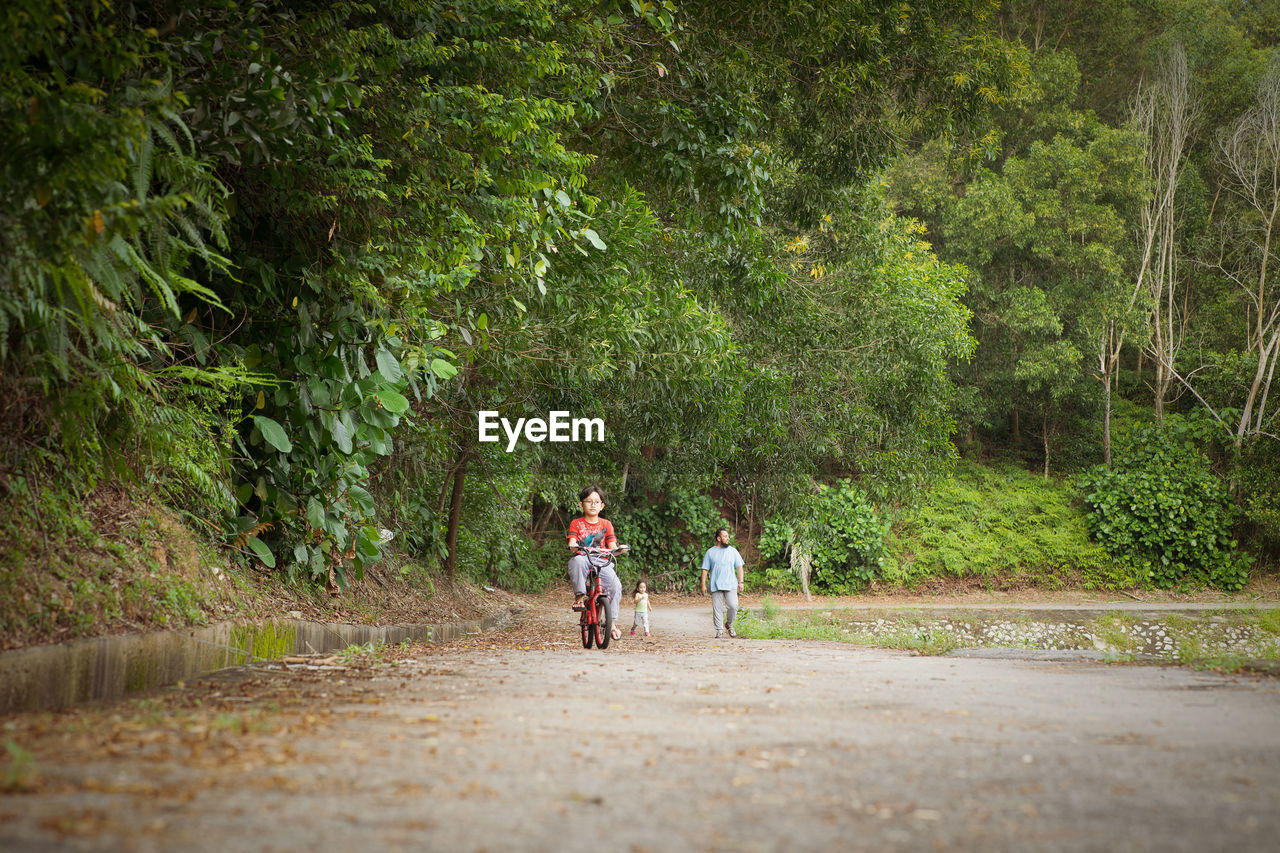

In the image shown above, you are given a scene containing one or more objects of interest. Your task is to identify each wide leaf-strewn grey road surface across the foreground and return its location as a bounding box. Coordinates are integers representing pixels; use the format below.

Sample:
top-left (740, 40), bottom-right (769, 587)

top-left (0, 607), bottom-right (1280, 853)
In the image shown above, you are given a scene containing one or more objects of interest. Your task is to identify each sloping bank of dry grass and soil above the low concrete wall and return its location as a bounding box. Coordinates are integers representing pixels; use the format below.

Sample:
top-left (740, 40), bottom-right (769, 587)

top-left (0, 478), bottom-right (481, 649)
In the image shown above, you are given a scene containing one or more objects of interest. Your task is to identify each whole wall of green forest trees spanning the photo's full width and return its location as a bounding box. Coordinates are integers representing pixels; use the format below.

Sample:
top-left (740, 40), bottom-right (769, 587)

top-left (0, 0), bottom-right (1280, 607)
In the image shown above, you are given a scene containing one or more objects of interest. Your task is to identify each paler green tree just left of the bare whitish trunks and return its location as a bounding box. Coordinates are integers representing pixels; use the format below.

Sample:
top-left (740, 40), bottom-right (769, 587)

top-left (890, 51), bottom-right (1144, 474)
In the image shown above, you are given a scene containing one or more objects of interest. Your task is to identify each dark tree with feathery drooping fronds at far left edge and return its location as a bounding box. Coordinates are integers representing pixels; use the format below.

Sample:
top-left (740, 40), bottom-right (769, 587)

top-left (0, 3), bottom-right (243, 507)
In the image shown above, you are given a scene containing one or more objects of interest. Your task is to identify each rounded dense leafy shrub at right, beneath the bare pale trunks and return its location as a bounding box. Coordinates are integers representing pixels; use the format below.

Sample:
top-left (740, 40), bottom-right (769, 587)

top-left (1080, 425), bottom-right (1248, 589)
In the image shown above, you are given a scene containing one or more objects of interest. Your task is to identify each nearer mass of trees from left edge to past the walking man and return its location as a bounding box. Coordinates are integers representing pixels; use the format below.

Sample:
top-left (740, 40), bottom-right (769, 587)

top-left (0, 0), bottom-right (1018, 591)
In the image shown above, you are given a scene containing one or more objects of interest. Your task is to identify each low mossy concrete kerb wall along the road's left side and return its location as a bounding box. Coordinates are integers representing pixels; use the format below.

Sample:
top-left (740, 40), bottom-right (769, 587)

top-left (0, 608), bottom-right (518, 713)
